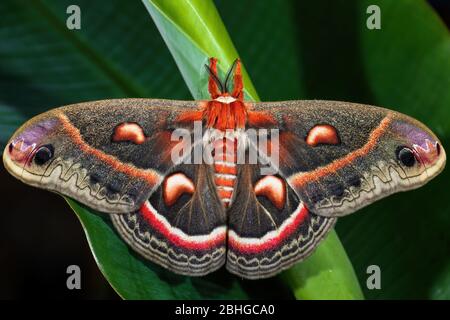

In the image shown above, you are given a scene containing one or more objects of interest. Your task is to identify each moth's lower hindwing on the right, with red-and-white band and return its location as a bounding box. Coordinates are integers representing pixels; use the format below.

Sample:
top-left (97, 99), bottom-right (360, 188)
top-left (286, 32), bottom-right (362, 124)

top-left (226, 165), bottom-right (336, 279)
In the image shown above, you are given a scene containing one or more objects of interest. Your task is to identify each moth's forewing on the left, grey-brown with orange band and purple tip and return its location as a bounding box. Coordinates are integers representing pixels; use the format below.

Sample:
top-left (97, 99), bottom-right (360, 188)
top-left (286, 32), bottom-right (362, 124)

top-left (3, 99), bottom-right (198, 213)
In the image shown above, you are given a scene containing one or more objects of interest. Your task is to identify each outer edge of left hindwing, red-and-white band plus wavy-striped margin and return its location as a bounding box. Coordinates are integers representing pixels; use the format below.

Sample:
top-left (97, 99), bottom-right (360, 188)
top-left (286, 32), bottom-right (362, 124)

top-left (111, 201), bottom-right (226, 276)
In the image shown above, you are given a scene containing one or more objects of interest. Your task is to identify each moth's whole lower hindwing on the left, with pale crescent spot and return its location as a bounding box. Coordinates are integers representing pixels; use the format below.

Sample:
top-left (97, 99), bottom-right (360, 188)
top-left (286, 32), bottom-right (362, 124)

top-left (111, 164), bottom-right (227, 276)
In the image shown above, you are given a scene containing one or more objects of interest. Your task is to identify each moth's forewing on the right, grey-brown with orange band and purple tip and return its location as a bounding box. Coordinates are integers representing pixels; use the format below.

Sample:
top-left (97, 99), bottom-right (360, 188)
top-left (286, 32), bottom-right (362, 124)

top-left (253, 101), bottom-right (446, 216)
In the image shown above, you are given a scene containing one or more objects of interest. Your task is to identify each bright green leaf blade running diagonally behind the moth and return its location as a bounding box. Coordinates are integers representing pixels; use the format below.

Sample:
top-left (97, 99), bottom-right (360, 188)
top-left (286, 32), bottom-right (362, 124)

top-left (143, 0), bottom-right (363, 299)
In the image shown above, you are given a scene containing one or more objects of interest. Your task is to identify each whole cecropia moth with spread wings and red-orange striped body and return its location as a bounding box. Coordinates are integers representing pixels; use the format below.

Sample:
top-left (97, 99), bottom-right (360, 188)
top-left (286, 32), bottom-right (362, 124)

top-left (3, 58), bottom-right (446, 279)
